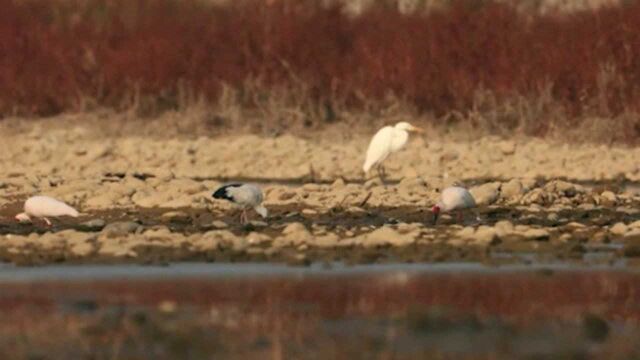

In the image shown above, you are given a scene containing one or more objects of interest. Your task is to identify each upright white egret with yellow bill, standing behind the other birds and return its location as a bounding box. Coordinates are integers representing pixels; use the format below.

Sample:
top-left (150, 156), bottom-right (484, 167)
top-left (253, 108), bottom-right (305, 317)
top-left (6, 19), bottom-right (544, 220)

top-left (362, 121), bottom-right (423, 178)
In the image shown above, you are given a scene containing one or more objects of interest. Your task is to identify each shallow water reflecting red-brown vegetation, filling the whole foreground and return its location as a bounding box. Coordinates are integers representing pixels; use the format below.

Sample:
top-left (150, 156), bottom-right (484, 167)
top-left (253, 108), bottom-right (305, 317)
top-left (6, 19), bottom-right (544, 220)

top-left (0, 262), bottom-right (640, 359)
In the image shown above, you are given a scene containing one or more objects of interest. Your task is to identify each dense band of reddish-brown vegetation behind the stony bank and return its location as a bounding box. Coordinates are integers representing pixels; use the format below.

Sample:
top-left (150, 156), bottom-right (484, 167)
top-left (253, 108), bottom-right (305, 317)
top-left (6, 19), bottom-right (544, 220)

top-left (0, 0), bottom-right (640, 131)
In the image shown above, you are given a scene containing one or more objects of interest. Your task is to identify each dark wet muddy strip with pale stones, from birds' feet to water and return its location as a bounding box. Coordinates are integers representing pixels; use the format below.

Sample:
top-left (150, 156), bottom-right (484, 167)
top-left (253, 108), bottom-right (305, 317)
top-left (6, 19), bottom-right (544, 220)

top-left (0, 190), bottom-right (640, 266)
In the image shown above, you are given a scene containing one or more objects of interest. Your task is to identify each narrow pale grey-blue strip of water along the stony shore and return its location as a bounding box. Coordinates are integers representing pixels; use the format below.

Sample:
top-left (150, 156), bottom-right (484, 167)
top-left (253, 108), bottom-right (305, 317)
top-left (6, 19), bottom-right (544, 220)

top-left (0, 253), bottom-right (640, 283)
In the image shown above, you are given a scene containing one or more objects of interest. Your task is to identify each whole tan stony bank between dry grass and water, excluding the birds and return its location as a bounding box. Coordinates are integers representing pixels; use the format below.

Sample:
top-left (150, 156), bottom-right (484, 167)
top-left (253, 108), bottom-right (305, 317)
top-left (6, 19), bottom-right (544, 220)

top-left (0, 116), bottom-right (640, 264)
